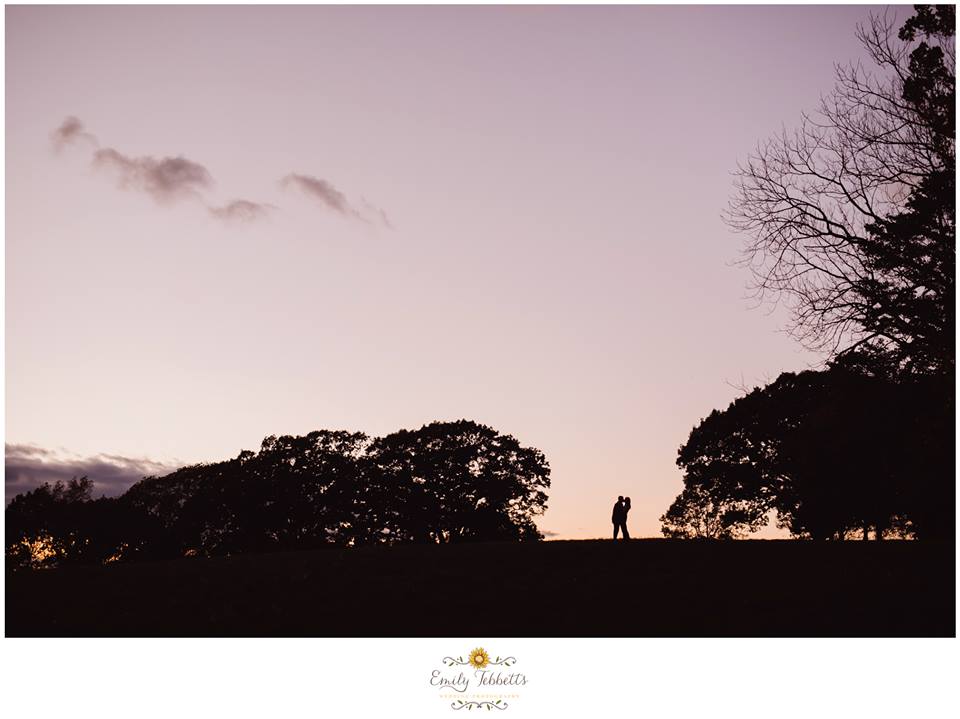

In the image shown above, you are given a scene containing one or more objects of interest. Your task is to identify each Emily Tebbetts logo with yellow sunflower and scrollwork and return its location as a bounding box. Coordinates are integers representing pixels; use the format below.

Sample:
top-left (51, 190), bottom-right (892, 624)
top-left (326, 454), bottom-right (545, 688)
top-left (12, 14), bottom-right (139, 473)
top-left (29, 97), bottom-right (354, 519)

top-left (430, 647), bottom-right (529, 711)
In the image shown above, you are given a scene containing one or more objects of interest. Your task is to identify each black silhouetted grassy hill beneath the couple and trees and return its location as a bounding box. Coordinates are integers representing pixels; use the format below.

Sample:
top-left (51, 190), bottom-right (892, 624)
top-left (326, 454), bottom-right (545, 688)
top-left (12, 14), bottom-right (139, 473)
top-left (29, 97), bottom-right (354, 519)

top-left (6, 539), bottom-right (955, 637)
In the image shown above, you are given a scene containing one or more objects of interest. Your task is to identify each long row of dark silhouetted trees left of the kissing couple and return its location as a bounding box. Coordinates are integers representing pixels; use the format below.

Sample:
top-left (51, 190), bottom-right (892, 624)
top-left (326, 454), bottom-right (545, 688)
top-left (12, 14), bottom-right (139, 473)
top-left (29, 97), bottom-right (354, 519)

top-left (6, 420), bottom-right (550, 568)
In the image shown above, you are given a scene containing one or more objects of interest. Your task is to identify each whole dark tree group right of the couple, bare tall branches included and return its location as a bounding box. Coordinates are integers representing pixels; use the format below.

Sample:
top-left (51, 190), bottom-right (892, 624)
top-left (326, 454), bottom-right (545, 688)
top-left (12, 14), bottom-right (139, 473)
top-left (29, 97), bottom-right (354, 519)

top-left (661, 5), bottom-right (956, 539)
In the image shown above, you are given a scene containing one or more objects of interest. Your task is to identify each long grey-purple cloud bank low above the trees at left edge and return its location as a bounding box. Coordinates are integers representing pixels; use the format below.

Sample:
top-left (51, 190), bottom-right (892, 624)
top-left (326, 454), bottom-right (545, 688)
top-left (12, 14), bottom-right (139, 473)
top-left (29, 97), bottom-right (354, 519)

top-left (5, 444), bottom-right (176, 502)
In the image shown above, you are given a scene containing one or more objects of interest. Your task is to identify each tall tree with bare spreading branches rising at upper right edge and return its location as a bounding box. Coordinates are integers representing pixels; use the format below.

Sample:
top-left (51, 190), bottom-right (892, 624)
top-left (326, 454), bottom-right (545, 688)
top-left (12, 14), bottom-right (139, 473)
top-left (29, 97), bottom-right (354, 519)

top-left (728, 5), bottom-right (956, 376)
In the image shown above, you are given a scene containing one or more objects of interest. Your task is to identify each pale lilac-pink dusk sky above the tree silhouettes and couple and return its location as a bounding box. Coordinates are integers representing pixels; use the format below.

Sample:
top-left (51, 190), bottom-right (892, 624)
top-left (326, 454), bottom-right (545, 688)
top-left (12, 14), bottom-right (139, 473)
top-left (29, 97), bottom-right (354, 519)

top-left (5, 6), bottom-right (888, 538)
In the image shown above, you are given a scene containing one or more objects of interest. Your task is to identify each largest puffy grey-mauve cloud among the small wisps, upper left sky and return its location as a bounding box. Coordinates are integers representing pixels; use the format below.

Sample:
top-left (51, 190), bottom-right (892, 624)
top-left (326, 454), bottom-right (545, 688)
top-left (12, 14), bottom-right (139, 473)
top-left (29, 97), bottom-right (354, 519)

top-left (93, 148), bottom-right (213, 203)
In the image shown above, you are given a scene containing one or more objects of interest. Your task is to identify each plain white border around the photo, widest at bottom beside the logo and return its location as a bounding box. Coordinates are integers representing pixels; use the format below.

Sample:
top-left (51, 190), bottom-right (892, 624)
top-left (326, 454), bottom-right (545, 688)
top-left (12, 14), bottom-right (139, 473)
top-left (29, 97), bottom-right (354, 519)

top-left (0, 2), bottom-right (960, 719)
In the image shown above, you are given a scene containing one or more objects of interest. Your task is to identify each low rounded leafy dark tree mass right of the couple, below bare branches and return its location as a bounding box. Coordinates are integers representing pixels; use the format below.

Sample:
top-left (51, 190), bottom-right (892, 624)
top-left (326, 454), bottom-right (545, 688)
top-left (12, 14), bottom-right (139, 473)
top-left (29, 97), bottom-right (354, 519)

top-left (661, 366), bottom-right (952, 539)
